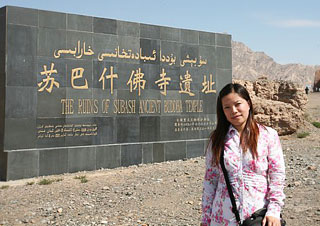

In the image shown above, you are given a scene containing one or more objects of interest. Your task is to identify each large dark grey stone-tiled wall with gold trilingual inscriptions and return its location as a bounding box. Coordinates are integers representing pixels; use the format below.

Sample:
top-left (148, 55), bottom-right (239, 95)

top-left (0, 6), bottom-right (232, 180)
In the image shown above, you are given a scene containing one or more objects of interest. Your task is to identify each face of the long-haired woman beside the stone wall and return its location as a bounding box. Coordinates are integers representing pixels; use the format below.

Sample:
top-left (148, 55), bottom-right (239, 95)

top-left (221, 93), bottom-right (250, 132)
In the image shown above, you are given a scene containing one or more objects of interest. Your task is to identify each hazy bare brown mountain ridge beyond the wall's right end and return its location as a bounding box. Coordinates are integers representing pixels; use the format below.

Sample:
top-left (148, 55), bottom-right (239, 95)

top-left (232, 41), bottom-right (320, 86)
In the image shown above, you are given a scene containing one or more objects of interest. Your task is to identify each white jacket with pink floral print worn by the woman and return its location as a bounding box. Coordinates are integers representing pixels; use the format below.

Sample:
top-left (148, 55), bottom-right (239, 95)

top-left (202, 125), bottom-right (285, 226)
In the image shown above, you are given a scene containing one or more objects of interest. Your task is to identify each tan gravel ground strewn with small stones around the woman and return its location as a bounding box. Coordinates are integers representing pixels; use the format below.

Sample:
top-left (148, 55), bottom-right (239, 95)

top-left (0, 93), bottom-right (320, 226)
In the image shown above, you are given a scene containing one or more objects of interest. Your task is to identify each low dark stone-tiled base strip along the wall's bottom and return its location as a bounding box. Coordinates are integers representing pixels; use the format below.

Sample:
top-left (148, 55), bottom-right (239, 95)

top-left (0, 139), bottom-right (207, 181)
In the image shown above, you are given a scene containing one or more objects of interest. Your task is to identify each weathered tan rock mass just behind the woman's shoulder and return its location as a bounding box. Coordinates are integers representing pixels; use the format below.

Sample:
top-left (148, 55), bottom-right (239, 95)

top-left (234, 77), bottom-right (307, 135)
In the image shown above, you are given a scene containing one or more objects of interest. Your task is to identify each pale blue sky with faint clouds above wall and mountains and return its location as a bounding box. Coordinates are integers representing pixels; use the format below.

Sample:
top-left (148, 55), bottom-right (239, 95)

top-left (0, 0), bottom-right (320, 65)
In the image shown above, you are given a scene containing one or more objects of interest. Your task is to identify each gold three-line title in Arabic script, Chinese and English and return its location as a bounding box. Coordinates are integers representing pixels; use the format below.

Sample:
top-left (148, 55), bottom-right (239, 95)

top-left (37, 41), bottom-right (216, 120)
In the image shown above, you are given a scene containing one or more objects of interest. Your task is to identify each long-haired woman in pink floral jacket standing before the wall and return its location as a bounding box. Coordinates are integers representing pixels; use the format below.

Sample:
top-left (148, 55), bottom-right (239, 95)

top-left (201, 83), bottom-right (285, 226)
